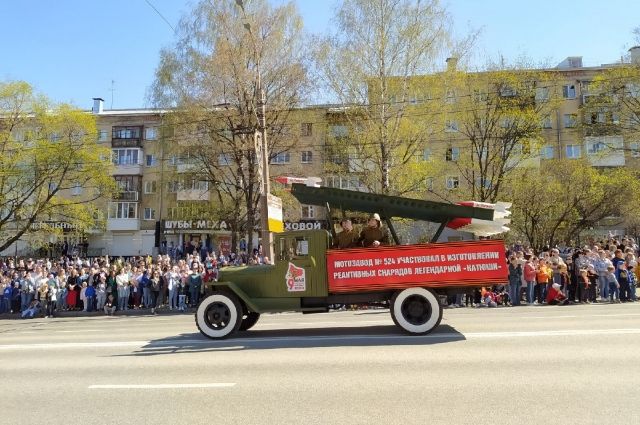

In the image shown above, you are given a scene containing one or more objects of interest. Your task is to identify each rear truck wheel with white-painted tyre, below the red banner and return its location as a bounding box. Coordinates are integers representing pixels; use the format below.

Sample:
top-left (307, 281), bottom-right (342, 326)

top-left (391, 288), bottom-right (442, 335)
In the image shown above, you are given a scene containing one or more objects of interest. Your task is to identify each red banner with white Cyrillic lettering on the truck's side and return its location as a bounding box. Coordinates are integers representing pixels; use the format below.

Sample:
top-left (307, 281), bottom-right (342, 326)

top-left (327, 240), bottom-right (508, 293)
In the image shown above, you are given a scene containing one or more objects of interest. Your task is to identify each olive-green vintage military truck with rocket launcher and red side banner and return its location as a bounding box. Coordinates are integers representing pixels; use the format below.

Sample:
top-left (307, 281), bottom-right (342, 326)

top-left (195, 184), bottom-right (508, 339)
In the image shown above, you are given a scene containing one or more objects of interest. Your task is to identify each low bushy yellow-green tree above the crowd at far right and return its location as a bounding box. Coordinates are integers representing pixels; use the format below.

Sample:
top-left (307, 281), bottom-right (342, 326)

top-left (509, 160), bottom-right (640, 249)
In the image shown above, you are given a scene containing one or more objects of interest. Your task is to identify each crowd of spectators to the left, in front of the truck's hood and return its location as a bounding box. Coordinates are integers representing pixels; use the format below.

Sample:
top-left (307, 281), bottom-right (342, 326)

top-left (0, 250), bottom-right (269, 318)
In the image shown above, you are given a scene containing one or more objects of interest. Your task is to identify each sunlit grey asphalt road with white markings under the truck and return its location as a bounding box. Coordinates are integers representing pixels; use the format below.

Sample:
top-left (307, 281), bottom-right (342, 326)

top-left (0, 303), bottom-right (640, 425)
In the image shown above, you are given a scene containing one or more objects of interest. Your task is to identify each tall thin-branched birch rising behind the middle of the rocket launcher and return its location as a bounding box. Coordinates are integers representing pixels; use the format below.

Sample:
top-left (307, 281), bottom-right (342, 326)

top-left (315, 0), bottom-right (470, 195)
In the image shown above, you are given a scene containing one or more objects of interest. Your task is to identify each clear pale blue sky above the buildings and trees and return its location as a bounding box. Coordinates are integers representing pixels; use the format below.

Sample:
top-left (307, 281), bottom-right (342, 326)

top-left (0, 0), bottom-right (640, 109)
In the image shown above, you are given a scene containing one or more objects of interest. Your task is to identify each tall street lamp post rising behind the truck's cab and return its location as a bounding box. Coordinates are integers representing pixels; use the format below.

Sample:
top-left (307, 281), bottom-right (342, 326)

top-left (236, 0), bottom-right (274, 261)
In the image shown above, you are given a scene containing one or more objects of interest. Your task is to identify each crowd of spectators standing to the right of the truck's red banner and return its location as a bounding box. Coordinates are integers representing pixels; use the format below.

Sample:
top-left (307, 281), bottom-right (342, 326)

top-left (449, 237), bottom-right (639, 308)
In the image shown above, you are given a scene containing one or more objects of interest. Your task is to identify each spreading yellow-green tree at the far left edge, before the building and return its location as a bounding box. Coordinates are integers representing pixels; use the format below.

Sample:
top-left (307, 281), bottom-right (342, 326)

top-left (0, 81), bottom-right (115, 251)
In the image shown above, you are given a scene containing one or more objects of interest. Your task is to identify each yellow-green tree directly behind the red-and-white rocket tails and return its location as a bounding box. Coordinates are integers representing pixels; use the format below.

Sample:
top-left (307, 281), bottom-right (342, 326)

top-left (436, 66), bottom-right (561, 203)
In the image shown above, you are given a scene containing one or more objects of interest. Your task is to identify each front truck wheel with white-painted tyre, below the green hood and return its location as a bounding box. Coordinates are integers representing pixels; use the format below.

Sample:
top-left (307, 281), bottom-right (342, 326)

top-left (196, 292), bottom-right (242, 339)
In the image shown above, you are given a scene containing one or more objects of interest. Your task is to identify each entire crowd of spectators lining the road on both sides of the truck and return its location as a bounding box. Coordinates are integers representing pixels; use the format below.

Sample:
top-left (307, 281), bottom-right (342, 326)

top-left (0, 238), bottom-right (638, 318)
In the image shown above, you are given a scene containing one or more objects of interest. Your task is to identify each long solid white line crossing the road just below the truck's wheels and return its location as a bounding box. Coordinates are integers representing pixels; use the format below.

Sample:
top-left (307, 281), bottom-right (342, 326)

top-left (0, 328), bottom-right (640, 351)
